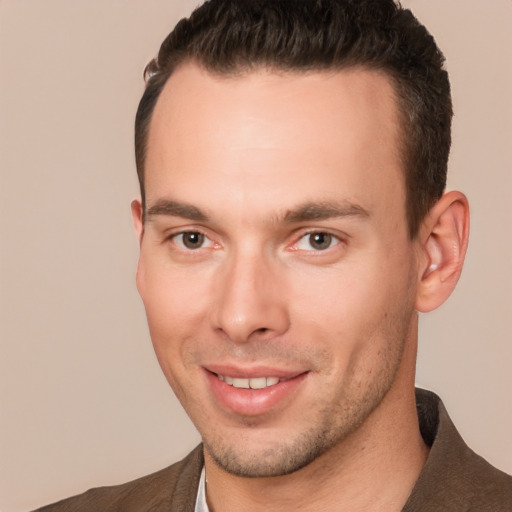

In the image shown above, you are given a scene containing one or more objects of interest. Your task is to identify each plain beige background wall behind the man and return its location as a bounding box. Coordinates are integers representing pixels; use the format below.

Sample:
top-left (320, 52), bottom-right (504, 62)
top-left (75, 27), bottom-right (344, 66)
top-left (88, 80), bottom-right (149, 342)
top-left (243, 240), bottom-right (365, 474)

top-left (0, 0), bottom-right (512, 512)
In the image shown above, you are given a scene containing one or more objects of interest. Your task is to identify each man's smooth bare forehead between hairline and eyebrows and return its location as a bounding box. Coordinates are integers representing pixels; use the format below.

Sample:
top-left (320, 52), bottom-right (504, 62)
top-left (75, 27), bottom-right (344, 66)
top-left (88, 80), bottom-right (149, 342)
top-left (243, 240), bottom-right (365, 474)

top-left (145, 63), bottom-right (404, 224)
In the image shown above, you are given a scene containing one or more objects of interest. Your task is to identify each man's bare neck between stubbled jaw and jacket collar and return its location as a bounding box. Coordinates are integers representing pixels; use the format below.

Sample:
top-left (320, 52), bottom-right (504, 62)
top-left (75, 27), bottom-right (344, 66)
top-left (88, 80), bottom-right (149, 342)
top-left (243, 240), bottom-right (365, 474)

top-left (205, 322), bottom-right (428, 512)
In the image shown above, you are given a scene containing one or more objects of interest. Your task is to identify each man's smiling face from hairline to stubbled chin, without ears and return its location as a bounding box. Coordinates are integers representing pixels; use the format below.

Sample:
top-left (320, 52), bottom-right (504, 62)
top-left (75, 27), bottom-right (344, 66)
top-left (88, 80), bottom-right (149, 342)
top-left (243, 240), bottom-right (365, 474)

top-left (135, 64), bottom-right (422, 476)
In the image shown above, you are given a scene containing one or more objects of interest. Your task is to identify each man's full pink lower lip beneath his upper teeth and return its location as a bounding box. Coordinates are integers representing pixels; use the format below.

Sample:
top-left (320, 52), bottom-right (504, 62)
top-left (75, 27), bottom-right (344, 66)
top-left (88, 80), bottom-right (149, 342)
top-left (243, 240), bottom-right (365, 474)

top-left (206, 371), bottom-right (307, 416)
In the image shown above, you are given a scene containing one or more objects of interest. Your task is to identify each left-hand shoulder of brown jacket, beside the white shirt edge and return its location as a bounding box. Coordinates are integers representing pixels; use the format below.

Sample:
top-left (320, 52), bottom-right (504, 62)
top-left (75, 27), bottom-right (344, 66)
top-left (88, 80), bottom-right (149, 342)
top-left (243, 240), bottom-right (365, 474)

top-left (31, 446), bottom-right (203, 512)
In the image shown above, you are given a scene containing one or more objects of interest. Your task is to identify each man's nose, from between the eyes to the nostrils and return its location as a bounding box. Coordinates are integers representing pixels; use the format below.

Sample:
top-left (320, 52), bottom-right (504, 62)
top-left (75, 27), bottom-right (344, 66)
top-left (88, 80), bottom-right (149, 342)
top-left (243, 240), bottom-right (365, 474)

top-left (212, 249), bottom-right (290, 343)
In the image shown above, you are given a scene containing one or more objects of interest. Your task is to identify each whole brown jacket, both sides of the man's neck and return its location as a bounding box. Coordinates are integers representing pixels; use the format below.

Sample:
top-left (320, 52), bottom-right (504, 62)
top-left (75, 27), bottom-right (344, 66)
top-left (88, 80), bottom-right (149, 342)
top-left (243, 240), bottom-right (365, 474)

top-left (39, 389), bottom-right (512, 512)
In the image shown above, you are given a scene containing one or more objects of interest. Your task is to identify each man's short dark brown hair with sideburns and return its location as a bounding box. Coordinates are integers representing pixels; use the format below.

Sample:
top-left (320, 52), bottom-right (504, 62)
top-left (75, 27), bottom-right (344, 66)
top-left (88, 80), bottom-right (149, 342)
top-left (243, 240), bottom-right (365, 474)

top-left (135, 0), bottom-right (452, 237)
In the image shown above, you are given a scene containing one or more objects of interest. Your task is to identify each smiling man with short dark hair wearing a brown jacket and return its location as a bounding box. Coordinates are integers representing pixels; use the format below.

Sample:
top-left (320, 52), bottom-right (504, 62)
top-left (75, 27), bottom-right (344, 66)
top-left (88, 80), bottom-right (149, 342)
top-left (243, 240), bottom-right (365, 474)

top-left (34, 0), bottom-right (512, 512)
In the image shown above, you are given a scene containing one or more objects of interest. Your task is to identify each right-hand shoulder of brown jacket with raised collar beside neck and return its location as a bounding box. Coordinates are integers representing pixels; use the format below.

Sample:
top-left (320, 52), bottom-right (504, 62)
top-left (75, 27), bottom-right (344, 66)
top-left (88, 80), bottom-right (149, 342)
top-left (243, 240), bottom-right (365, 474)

top-left (404, 390), bottom-right (512, 512)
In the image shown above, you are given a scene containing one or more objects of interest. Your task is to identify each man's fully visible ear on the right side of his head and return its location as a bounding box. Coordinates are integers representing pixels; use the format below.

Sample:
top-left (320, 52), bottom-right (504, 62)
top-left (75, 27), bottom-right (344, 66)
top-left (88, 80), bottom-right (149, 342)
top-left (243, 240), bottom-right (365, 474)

top-left (416, 191), bottom-right (469, 313)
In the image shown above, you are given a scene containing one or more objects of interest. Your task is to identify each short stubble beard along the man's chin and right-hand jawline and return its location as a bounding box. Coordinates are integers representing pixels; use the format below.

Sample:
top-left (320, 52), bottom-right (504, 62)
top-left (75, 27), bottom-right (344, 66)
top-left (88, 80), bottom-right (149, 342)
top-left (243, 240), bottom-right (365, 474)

top-left (201, 269), bottom-right (417, 478)
